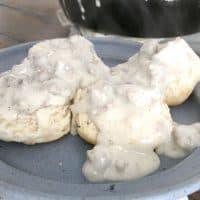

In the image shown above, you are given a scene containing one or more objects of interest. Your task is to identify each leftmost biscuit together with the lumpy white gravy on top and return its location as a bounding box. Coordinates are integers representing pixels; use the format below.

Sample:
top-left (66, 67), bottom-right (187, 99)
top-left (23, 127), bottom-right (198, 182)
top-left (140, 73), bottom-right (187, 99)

top-left (0, 36), bottom-right (109, 144)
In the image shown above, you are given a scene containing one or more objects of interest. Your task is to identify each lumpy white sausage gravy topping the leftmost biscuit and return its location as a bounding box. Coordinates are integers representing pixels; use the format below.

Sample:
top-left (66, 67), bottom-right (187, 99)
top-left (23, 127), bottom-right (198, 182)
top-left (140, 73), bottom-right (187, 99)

top-left (0, 36), bottom-right (109, 120)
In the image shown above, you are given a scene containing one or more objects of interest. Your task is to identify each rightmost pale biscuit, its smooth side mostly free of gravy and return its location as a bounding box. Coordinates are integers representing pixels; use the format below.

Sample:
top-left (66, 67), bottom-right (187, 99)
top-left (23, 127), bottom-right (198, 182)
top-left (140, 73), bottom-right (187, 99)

top-left (150, 38), bottom-right (200, 106)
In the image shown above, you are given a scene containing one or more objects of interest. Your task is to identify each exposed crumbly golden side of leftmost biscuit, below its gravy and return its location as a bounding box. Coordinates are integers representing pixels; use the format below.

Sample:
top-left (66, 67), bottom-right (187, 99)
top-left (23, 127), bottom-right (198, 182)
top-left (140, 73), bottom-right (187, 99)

top-left (0, 106), bottom-right (71, 145)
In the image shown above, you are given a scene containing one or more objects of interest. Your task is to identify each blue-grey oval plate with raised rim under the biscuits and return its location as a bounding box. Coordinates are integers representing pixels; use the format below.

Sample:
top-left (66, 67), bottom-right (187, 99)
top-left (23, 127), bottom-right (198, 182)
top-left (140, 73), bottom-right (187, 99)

top-left (0, 38), bottom-right (200, 200)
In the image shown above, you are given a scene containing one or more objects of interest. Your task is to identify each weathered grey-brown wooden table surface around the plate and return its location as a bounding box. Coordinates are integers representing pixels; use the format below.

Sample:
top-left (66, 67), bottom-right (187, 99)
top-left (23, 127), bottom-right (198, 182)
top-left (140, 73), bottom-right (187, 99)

top-left (0, 0), bottom-right (200, 200)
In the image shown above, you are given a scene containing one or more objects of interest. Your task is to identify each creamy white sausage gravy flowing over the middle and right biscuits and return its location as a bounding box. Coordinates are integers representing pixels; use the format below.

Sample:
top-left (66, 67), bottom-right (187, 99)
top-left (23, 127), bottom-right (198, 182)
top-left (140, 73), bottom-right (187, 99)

top-left (73, 39), bottom-right (200, 182)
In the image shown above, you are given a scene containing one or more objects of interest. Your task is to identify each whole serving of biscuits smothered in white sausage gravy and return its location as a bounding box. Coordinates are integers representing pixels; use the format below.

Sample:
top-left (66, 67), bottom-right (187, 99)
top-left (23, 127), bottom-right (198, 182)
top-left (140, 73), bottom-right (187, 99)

top-left (0, 36), bottom-right (200, 182)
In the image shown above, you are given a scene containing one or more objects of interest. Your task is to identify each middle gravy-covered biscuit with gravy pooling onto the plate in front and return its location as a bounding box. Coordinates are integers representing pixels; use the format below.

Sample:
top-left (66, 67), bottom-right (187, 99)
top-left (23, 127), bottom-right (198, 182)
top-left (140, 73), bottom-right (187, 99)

top-left (72, 80), bottom-right (173, 181)
